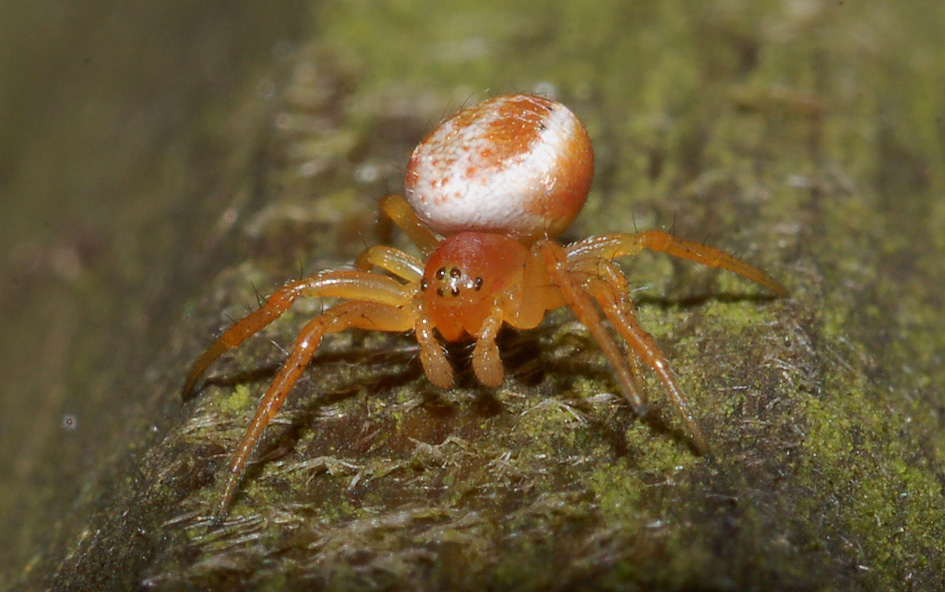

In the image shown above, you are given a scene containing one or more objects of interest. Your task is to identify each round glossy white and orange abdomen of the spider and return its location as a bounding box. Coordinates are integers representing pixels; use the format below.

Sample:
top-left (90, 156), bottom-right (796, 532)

top-left (405, 95), bottom-right (594, 244)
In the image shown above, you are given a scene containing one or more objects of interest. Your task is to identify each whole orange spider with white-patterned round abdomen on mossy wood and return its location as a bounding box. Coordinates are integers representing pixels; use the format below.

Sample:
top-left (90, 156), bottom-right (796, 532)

top-left (183, 94), bottom-right (787, 516)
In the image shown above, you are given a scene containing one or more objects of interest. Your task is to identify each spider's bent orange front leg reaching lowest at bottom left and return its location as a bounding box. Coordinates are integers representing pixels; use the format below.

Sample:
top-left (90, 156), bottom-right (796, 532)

top-left (217, 302), bottom-right (416, 517)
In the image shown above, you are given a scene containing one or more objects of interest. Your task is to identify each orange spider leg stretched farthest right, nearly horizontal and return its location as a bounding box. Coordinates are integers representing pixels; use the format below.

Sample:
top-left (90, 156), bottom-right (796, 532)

top-left (568, 230), bottom-right (788, 296)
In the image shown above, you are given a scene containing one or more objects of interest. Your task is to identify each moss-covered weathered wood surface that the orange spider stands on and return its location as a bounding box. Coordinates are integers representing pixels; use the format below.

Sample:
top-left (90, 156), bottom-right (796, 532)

top-left (3, 0), bottom-right (945, 590)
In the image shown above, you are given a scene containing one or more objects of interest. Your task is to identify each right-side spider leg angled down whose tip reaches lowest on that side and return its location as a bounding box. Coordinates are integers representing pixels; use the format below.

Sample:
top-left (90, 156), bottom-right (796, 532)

top-left (591, 268), bottom-right (710, 453)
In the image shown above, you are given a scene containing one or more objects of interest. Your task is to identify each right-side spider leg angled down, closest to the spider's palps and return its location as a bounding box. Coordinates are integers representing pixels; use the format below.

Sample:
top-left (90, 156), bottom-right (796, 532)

top-left (532, 240), bottom-right (646, 417)
